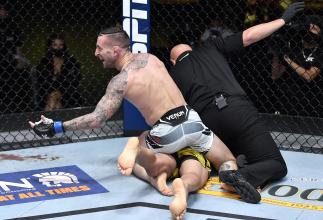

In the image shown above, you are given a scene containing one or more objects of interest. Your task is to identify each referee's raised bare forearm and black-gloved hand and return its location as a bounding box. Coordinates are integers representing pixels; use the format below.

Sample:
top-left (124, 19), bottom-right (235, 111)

top-left (242, 2), bottom-right (305, 47)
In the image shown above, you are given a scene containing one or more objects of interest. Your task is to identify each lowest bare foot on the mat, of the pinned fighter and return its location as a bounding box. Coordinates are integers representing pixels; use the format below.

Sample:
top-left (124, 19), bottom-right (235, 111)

top-left (169, 178), bottom-right (187, 220)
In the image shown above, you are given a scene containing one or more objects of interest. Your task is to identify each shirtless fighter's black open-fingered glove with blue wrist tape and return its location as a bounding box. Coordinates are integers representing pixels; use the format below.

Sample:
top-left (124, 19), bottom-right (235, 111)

top-left (33, 118), bottom-right (65, 138)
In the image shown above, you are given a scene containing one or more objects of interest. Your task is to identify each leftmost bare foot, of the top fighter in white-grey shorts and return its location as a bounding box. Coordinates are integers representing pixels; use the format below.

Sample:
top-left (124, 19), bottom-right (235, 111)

top-left (118, 138), bottom-right (139, 176)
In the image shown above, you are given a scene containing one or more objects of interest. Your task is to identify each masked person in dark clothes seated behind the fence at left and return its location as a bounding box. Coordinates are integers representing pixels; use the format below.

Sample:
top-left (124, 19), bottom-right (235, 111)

top-left (36, 34), bottom-right (81, 111)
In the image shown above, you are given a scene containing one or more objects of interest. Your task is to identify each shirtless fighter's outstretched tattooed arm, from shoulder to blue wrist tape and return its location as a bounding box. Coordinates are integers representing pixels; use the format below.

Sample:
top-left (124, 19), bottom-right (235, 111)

top-left (63, 70), bottom-right (128, 131)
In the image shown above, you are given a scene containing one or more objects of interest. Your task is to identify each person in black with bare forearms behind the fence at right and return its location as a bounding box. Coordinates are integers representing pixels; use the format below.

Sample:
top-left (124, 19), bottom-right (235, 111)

top-left (272, 15), bottom-right (323, 82)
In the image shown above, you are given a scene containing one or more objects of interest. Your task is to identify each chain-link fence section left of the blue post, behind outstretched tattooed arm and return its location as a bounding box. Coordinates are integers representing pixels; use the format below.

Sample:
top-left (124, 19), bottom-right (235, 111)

top-left (0, 0), bottom-right (122, 150)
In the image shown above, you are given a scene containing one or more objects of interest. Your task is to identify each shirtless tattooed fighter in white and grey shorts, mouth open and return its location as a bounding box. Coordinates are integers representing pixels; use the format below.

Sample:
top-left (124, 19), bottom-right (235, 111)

top-left (29, 27), bottom-right (260, 217)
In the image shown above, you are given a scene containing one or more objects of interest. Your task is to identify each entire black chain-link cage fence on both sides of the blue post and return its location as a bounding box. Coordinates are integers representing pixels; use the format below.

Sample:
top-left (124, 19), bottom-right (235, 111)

top-left (0, 0), bottom-right (323, 153)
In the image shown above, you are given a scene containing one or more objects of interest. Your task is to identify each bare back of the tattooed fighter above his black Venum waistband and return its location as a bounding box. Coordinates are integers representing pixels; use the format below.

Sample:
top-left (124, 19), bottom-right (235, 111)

top-left (120, 53), bottom-right (186, 125)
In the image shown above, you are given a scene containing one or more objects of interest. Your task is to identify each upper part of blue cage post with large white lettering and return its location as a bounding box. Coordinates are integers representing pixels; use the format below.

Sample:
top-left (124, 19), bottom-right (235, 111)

top-left (122, 0), bottom-right (150, 53)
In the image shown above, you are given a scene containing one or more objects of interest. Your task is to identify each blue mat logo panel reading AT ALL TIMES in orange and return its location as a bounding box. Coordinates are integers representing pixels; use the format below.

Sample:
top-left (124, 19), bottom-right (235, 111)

top-left (0, 165), bottom-right (109, 206)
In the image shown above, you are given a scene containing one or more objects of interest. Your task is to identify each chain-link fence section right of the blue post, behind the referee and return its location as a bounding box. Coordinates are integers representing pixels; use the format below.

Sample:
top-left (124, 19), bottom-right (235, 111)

top-left (151, 0), bottom-right (323, 153)
